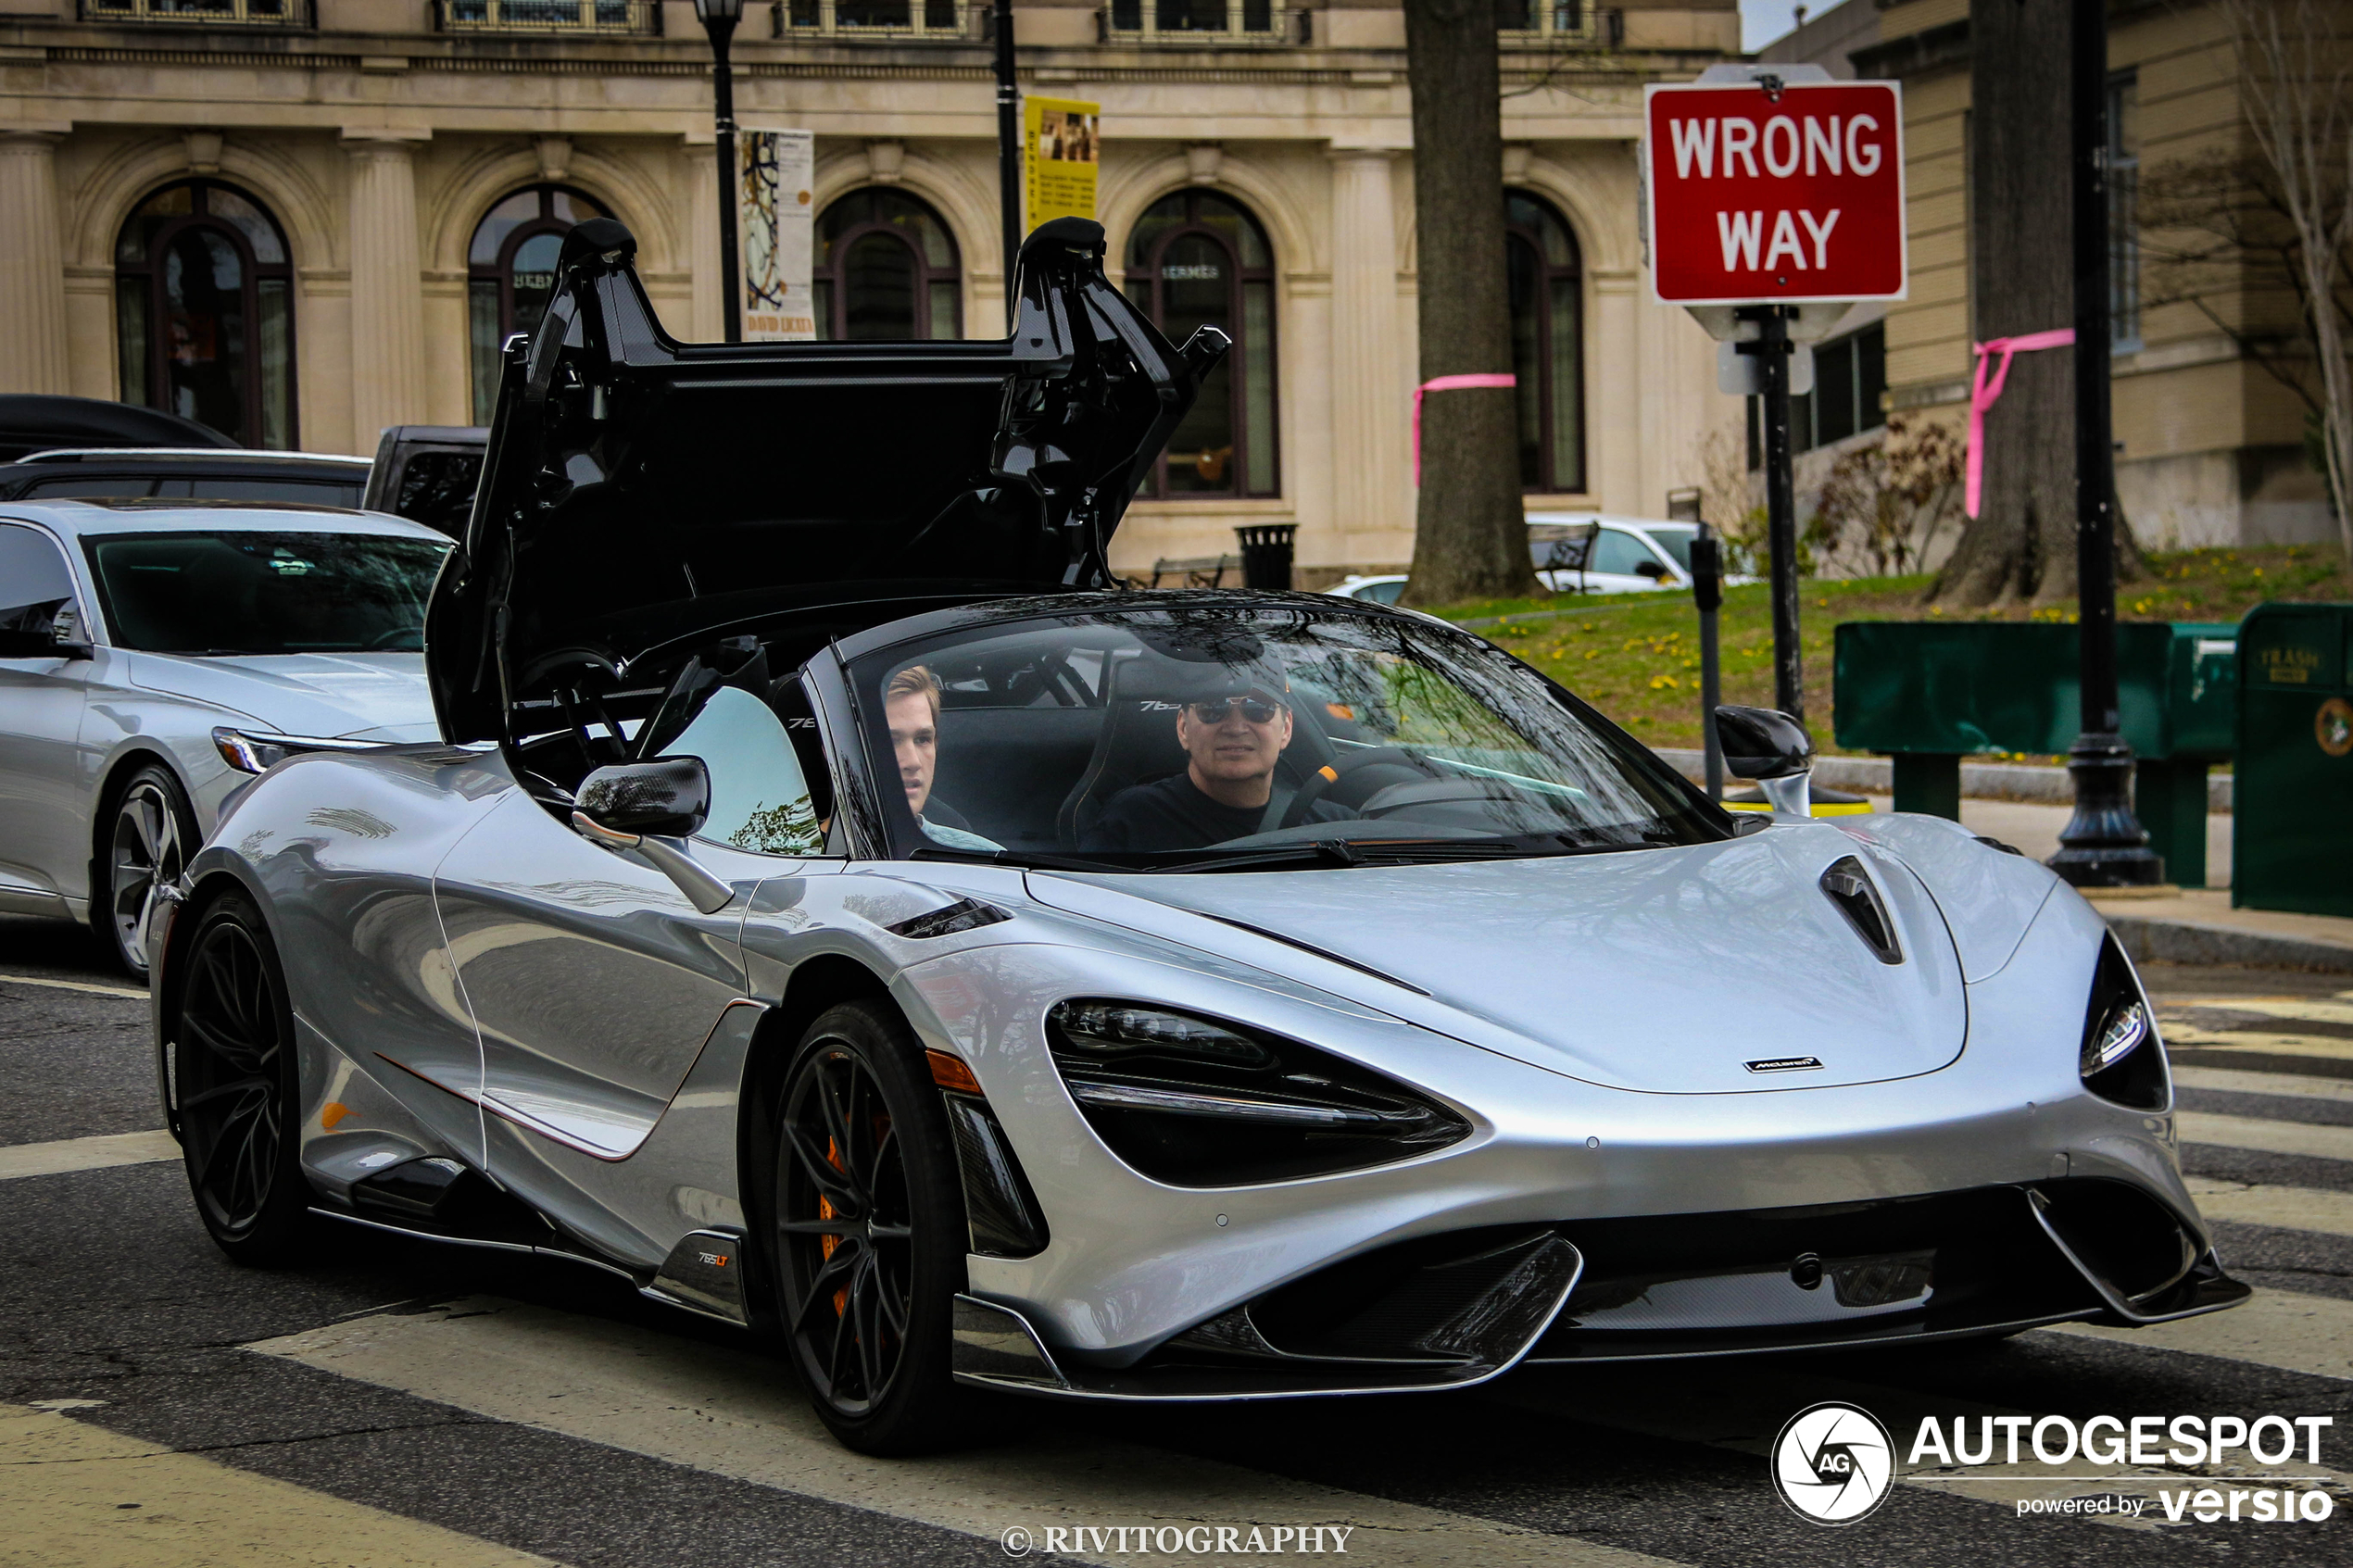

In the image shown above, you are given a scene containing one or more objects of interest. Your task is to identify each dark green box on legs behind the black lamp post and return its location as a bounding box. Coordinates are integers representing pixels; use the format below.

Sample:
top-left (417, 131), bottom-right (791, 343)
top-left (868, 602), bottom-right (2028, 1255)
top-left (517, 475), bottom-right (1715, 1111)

top-left (1833, 621), bottom-right (2238, 886)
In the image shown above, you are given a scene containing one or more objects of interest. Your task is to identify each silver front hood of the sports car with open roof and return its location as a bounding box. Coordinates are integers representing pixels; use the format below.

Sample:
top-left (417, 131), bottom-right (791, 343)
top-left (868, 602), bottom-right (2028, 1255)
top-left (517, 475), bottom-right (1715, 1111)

top-left (1028, 822), bottom-right (1967, 1093)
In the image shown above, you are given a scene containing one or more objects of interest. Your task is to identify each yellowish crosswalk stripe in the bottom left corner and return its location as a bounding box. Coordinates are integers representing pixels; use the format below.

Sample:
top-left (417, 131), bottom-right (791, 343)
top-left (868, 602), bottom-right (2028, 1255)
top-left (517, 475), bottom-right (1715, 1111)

top-left (0, 1403), bottom-right (548, 1568)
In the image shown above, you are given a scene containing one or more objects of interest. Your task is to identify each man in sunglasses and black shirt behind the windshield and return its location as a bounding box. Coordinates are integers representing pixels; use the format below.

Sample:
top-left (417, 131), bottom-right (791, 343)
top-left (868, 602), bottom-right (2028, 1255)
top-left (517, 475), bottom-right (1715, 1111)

top-left (1092, 670), bottom-right (1348, 851)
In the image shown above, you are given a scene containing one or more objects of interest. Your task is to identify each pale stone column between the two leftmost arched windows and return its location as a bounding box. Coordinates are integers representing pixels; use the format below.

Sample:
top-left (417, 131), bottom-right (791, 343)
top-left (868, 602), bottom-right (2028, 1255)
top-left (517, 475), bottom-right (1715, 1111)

top-left (344, 132), bottom-right (431, 454)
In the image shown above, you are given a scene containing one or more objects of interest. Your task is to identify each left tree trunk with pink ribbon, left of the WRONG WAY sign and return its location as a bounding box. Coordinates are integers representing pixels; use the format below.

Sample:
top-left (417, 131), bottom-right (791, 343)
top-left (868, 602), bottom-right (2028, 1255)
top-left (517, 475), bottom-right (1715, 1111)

top-left (1404, 0), bottom-right (1537, 604)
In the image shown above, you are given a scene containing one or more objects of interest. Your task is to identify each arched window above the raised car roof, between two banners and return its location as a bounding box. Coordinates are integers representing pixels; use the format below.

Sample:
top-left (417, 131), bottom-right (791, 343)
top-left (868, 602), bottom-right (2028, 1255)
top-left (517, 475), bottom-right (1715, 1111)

top-left (812, 191), bottom-right (964, 341)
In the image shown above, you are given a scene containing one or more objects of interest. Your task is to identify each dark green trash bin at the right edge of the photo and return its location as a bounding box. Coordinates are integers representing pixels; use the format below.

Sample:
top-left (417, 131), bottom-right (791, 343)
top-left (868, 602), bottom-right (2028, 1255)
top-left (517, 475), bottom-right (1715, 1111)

top-left (2231, 604), bottom-right (2353, 914)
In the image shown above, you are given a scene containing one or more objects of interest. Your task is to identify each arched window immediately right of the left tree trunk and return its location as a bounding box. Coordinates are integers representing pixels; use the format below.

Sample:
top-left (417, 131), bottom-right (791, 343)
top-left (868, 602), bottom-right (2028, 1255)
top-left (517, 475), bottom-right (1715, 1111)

top-left (1504, 191), bottom-right (1586, 494)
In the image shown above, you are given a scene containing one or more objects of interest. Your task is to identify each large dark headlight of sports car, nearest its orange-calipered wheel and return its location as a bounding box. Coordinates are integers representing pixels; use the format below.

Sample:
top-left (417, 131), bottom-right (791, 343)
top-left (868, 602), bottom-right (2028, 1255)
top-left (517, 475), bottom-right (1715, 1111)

top-left (1047, 999), bottom-right (1471, 1187)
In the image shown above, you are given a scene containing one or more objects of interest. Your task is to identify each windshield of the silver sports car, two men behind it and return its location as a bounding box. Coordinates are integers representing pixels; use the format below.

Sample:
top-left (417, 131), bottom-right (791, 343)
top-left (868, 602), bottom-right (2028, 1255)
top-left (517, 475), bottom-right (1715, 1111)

top-left (854, 604), bottom-right (1731, 870)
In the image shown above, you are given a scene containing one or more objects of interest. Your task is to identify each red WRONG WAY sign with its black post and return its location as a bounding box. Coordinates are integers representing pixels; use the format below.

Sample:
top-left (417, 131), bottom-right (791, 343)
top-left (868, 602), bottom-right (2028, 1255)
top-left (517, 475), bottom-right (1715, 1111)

top-left (1642, 66), bottom-right (1908, 720)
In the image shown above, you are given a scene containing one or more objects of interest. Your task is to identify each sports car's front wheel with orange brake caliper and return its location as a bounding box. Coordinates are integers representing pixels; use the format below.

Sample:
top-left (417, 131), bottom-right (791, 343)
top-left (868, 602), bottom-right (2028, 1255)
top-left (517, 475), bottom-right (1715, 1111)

top-left (765, 1001), bottom-right (967, 1455)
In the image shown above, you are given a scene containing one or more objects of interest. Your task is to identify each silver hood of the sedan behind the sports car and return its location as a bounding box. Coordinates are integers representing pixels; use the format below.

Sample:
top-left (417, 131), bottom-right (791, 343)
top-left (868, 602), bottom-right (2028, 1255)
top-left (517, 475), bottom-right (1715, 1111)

top-left (130, 654), bottom-right (440, 741)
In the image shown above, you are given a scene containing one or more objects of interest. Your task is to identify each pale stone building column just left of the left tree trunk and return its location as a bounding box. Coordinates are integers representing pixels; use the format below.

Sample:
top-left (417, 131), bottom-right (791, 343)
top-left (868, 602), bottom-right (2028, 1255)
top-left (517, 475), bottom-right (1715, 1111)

top-left (1332, 148), bottom-right (1415, 562)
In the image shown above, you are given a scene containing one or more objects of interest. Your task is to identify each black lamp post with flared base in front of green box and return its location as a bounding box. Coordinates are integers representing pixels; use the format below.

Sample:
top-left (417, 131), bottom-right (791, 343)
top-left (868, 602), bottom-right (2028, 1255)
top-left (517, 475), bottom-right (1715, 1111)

top-left (2049, 0), bottom-right (2165, 886)
